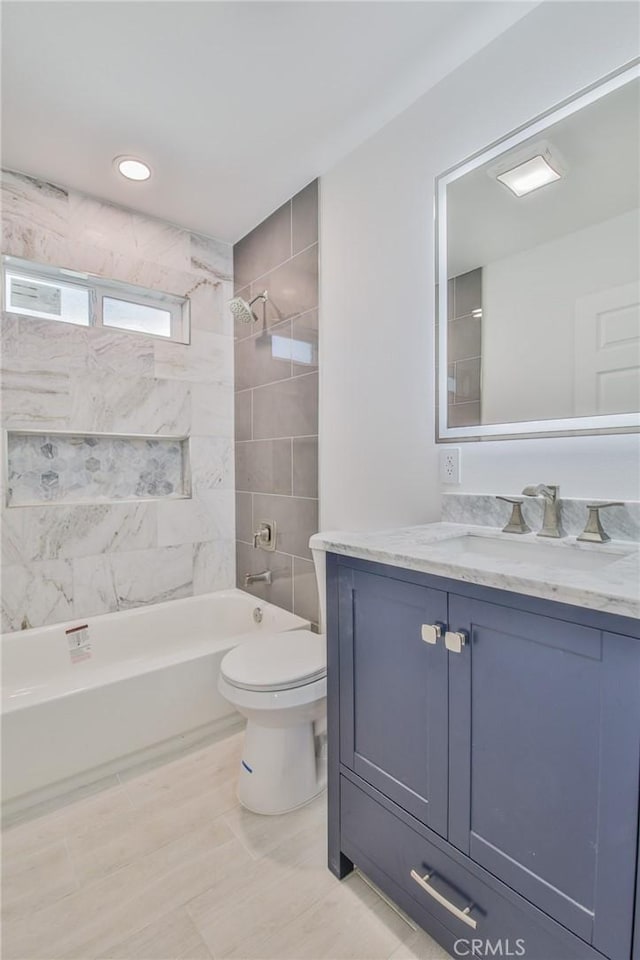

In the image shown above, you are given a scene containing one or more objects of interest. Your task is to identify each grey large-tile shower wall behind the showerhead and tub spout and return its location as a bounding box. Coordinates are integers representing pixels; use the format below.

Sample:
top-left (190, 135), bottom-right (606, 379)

top-left (233, 181), bottom-right (318, 622)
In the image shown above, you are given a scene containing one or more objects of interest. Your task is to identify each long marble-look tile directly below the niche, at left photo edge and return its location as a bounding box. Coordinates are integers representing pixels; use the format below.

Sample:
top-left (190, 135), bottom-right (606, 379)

top-left (1, 503), bottom-right (156, 564)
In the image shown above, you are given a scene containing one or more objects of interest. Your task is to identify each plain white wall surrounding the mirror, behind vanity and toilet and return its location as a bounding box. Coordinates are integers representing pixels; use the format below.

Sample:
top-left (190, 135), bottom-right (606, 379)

top-left (320, 2), bottom-right (640, 529)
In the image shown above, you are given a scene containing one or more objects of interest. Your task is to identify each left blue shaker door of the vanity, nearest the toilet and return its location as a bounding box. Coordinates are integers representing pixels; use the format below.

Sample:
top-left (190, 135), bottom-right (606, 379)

top-left (339, 568), bottom-right (448, 836)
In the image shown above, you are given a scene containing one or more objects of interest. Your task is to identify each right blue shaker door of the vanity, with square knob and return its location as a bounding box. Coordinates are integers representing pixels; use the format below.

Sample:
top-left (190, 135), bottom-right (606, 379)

top-left (449, 597), bottom-right (640, 960)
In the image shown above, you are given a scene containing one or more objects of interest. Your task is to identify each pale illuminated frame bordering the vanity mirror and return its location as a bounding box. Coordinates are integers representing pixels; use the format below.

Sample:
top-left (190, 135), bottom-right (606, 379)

top-left (434, 58), bottom-right (640, 443)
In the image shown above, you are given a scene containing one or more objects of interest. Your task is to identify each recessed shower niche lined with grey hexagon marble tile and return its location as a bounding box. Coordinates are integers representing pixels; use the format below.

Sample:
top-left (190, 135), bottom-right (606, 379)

top-left (7, 431), bottom-right (190, 507)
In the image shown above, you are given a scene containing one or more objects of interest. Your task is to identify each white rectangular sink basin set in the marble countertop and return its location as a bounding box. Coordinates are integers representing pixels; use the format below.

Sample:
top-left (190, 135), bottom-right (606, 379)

top-left (430, 534), bottom-right (634, 570)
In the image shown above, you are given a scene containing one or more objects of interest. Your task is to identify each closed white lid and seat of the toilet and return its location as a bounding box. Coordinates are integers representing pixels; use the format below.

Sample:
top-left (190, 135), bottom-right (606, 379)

top-left (220, 630), bottom-right (327, 691)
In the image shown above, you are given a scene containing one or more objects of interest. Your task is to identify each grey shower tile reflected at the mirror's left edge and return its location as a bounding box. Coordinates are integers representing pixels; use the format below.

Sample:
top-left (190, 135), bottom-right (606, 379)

top-left (447, 267), bottom-right (482, 427)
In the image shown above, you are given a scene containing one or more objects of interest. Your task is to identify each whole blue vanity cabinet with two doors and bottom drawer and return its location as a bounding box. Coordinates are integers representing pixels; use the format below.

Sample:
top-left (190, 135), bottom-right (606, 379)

top-left (327, 555), bottom-right (640, 960)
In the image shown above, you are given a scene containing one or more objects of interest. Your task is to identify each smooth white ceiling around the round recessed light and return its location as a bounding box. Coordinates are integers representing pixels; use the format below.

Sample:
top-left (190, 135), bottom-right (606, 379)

top-left (2, 0), bottom-right (536, 241)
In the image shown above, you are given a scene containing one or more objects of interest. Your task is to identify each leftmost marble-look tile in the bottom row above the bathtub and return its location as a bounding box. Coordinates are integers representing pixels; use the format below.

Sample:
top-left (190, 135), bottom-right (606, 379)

top-left (2, 560), bottom-right (73, 631)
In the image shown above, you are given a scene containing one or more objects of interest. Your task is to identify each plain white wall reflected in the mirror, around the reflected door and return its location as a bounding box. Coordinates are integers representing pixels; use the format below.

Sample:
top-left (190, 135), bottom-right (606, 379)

top-left (482, 210), bottom-right (640, 423)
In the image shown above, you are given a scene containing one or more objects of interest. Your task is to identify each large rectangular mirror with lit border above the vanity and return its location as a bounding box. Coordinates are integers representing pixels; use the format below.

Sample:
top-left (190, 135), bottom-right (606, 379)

top-left (436, 56), bottom-right (640, 442)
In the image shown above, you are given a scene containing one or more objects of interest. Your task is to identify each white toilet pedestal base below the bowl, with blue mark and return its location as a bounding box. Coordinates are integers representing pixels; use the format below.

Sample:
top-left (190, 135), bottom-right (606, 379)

top-left (237, 719), bottom-right (326, 816)
